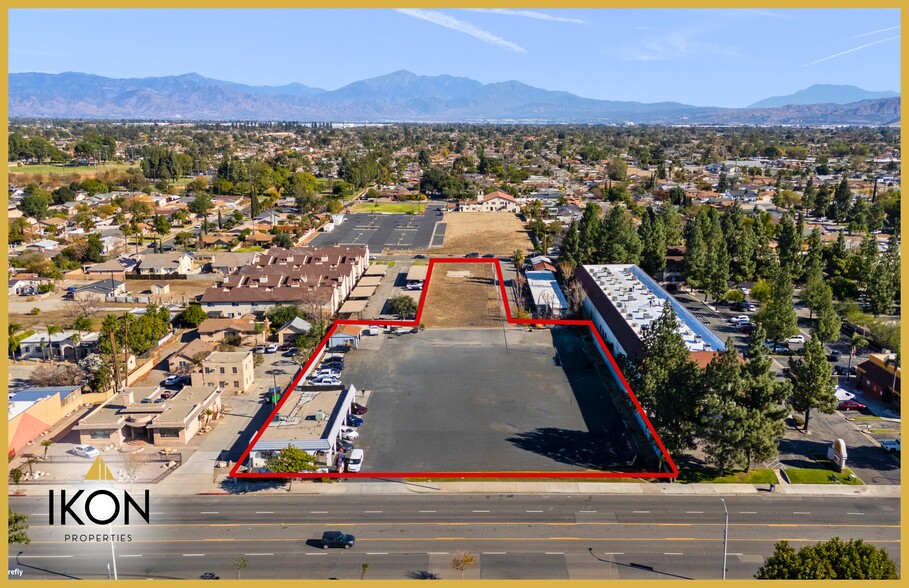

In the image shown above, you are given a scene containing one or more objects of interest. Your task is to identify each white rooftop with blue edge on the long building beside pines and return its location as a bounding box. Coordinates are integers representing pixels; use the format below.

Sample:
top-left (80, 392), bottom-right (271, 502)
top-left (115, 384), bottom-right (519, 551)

top-left (584, 264), bottom-right (726, 351)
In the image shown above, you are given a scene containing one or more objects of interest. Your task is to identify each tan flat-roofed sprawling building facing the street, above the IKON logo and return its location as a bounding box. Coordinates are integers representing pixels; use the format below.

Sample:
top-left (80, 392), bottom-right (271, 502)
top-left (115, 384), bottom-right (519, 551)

top-left (73, 386), bottom-right (222, 447)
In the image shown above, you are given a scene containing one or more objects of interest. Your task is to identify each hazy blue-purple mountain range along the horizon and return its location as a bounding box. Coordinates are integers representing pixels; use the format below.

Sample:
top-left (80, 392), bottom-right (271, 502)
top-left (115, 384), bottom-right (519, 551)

top-left (9, 70), bottom-right (900, 125)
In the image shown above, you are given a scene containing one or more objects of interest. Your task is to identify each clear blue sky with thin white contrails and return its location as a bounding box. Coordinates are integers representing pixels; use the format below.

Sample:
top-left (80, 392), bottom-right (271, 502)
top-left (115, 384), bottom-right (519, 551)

top-left (9, 9), bottom-right (901, 107)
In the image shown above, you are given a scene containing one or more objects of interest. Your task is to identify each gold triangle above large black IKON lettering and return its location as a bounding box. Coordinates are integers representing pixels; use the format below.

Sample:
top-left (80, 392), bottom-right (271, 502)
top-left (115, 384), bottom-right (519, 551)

top-left (48, 456), bottom-right (149, 525)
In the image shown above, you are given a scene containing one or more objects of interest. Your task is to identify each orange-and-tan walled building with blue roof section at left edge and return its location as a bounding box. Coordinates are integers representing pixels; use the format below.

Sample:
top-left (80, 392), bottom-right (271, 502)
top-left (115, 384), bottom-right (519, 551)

top-left (6, 386), bottom-right (82, 457)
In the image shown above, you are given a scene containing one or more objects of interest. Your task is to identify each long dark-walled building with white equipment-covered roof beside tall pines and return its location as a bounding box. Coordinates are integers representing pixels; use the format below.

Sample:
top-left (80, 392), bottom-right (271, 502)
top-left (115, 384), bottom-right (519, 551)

top-left (575, 264), bottom-right (726, 367)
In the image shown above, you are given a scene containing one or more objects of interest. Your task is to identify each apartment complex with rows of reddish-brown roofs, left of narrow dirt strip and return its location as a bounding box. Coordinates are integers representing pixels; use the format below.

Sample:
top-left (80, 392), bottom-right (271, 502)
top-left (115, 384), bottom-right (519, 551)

top-left (201, 245), bottom-right (369, 318)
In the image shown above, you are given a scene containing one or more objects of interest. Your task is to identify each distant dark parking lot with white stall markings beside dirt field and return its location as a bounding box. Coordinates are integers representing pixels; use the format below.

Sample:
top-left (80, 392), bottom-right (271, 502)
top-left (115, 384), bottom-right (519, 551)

top-left (310, 204), bottom-right (445, 254)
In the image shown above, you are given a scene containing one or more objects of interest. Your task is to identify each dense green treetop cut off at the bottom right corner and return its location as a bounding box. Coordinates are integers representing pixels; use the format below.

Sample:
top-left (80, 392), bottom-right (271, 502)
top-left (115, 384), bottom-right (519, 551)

top-left (754, 537), bottom-right (899, 580)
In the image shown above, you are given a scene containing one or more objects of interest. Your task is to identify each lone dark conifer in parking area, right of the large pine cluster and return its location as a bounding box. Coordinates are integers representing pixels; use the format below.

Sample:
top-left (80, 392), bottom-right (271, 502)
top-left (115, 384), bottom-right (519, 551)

top-left (789, 337), bottom-right (836, 432)
